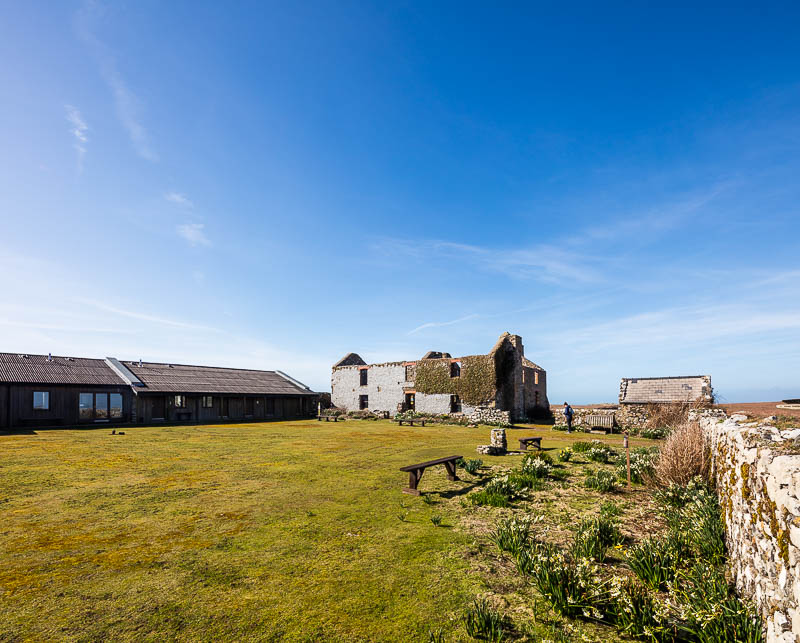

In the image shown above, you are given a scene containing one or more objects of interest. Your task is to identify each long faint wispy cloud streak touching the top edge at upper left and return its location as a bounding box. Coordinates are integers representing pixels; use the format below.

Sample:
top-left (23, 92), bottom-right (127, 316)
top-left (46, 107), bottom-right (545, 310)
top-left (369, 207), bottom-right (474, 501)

top-left (75, 0), bottom-right (158, 162)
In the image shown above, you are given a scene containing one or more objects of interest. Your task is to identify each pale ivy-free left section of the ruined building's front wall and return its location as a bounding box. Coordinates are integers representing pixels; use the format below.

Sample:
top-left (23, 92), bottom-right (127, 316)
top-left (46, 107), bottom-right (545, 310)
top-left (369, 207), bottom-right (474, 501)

top-left (331, 362), bottom-right (410, 414)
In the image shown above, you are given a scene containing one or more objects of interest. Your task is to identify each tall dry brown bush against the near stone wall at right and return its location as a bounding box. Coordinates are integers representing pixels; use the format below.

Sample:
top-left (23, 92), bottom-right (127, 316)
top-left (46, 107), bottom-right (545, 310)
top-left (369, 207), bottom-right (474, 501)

top-left (654, 422), bottom-right (709, 486)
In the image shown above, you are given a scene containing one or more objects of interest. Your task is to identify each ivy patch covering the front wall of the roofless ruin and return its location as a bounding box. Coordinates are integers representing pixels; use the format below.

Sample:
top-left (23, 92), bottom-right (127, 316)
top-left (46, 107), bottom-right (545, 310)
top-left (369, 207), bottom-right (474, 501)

top-left (414, 355), bottom-right (496, 406)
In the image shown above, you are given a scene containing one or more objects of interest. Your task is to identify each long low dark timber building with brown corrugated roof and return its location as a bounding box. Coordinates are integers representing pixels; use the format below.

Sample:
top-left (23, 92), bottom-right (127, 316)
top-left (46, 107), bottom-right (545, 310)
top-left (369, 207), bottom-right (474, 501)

top-left (0, 353), bottom-right (317, 429)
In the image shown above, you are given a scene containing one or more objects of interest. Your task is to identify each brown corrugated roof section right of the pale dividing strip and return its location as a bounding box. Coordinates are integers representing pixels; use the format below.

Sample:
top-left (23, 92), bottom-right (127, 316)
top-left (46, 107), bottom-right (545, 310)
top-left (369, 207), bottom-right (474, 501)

top-left (122, 362), bottom-right (314, 395)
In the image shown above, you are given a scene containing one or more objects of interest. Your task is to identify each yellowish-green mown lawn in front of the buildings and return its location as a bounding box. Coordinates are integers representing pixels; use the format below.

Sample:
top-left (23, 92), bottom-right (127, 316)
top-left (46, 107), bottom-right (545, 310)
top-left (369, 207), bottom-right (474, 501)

top-left (0, 420), bottom-right (660, 641)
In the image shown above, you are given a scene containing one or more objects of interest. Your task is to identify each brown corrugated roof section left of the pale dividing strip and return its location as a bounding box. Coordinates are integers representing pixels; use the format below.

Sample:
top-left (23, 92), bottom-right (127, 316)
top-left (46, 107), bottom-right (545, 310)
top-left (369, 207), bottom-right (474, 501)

top-left (0, 353), bottom-right (125, 386)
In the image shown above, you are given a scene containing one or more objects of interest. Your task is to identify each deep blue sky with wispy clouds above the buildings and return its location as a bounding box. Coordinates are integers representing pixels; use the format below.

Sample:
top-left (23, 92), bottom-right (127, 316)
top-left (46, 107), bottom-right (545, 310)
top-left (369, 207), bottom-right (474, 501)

top-left (0, 1), bottom-right (800, 403)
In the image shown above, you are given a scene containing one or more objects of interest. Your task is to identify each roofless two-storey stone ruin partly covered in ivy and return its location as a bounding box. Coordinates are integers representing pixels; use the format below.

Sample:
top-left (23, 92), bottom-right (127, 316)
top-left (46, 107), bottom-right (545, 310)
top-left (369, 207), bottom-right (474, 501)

top-left (331, 333), bottom-right (549, 422)
